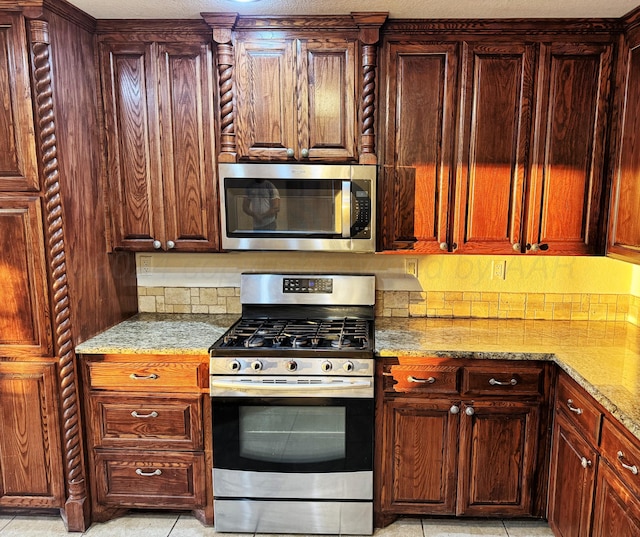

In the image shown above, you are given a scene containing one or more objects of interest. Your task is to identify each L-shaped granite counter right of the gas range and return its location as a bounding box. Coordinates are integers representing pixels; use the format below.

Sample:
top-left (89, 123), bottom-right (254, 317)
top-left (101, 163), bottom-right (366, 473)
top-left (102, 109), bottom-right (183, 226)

top-left (376, 318), bottom-right (640, 439)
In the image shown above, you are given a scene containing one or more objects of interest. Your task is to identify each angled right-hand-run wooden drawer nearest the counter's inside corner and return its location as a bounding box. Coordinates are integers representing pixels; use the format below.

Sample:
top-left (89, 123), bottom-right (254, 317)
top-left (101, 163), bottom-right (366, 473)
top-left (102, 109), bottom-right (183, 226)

top-left (556, 373), bottom-right (602, 446)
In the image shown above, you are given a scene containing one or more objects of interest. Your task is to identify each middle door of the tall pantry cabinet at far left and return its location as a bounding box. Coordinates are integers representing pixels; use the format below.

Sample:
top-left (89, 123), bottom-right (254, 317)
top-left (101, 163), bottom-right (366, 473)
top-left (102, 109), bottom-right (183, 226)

top-left (0, 194), bottom-right (51, 356)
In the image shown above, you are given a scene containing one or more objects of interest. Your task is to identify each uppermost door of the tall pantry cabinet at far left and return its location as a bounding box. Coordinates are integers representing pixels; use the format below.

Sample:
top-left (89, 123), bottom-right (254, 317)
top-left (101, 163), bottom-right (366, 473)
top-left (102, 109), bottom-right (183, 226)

top-left (0, 13), bottom-right (39, 191)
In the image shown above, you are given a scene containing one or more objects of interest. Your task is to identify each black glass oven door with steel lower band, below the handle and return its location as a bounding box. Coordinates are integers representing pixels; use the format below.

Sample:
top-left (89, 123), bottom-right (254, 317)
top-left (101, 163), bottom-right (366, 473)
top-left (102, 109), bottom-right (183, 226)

top-left (213, 397), bottom-right (374, 499)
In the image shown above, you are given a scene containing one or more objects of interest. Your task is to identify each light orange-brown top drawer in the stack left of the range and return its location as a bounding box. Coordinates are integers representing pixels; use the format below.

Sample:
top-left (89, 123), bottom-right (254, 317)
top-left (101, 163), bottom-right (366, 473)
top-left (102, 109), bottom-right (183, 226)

top-left (87, 360), bottom-right (202, 392)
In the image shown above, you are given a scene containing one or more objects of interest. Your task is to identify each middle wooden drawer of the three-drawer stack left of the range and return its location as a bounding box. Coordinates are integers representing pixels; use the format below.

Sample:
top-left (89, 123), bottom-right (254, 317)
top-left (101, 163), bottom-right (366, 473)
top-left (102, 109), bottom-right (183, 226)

top-left (91, 394), bottom-right (203, 451)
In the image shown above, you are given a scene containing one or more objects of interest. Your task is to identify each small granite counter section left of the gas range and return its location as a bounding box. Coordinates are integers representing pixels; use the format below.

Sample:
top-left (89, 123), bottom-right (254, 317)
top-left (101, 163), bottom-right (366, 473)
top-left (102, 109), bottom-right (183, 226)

top-left (76, 313), bottom-right (240, 354)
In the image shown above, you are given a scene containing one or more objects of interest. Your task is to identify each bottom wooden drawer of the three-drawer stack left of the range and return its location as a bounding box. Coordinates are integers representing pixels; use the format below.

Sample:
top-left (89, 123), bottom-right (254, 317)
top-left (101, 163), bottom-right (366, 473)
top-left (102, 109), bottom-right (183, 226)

top-left (96, 451), bottom-right (205, 509)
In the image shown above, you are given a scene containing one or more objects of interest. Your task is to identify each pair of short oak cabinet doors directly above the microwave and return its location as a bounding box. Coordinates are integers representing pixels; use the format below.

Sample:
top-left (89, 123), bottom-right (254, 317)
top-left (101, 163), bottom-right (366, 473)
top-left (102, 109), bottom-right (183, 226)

top-left (235, 38), bottom-right (357, 161)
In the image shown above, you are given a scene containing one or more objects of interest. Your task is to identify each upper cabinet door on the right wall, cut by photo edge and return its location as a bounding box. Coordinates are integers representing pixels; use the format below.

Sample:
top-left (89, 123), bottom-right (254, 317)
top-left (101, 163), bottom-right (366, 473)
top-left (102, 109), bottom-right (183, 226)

top-left (607, 42), bottom-right (640, 263)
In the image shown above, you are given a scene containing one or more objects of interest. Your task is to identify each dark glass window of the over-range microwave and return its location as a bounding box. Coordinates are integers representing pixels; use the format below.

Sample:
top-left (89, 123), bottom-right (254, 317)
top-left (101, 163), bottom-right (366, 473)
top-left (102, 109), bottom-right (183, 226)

top-left (224, 178), bottom-right (342, 237)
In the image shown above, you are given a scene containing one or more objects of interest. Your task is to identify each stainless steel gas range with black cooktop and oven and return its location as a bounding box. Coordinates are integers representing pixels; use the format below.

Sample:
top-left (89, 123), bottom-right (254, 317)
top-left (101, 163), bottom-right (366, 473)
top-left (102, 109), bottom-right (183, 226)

top-left (209, 274), bottom-right (375, 535)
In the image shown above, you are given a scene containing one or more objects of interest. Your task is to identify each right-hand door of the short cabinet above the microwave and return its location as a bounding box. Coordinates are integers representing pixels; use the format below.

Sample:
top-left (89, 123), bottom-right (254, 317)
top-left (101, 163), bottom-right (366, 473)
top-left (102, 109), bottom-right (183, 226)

top-left (296, 39), bottom-right (357, 161)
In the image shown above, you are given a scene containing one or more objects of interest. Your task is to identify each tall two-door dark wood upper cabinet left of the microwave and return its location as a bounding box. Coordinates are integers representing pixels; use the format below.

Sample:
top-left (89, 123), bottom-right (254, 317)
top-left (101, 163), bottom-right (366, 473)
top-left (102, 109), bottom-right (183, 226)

top-left (101, 37), bottom-right (218, 251)
